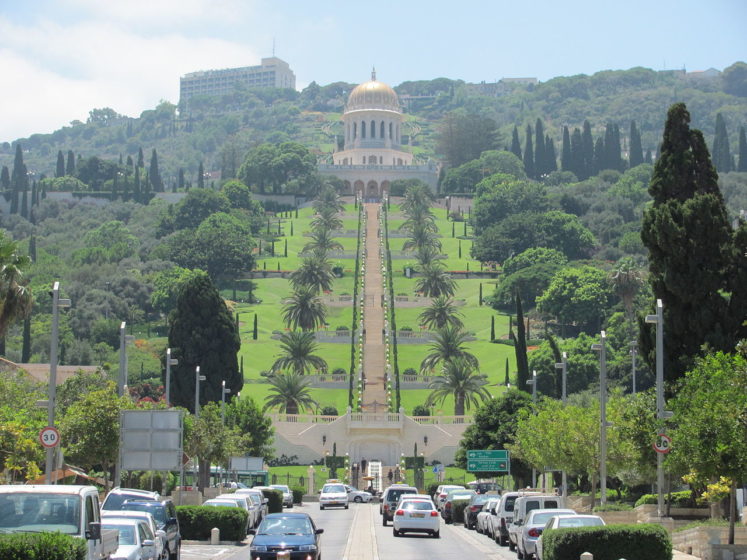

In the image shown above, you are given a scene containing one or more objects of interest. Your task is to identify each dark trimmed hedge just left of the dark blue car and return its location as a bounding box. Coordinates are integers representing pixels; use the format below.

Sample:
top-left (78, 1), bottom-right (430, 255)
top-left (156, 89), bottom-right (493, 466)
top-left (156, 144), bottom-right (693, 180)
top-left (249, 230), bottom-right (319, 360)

top-left (176, 506), bottom-right (249, 541)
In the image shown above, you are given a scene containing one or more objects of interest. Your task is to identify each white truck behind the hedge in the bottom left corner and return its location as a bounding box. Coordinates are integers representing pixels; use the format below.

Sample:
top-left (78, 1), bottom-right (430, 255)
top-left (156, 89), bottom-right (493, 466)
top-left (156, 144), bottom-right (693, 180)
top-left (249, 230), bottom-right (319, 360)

top-left (0, 484), bottom-right (119, 560)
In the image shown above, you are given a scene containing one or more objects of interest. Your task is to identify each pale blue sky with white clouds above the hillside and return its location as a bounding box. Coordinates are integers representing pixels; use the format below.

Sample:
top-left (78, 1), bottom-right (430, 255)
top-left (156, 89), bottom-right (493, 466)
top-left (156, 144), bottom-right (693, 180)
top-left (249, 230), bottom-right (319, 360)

top-left (0, 0), bottom-right (747, 141)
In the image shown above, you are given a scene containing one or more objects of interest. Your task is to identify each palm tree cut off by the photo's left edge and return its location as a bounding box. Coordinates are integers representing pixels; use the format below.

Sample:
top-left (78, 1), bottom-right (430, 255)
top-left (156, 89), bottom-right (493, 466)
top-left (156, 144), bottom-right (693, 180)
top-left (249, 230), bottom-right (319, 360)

top-left (0, 233), bottom-right (33, 338)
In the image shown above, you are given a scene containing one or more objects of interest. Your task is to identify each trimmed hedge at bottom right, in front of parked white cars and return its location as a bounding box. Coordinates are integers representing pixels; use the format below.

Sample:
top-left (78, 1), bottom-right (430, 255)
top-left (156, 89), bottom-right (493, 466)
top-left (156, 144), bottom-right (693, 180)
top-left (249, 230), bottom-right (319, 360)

top-left (542, 524), bottom-right (672, 560)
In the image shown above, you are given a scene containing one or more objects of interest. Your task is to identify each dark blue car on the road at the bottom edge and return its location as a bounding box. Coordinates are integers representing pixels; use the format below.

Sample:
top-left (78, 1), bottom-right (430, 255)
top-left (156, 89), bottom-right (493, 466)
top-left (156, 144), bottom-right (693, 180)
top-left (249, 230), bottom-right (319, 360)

top-left (249, 513), bottom-right (324, 560)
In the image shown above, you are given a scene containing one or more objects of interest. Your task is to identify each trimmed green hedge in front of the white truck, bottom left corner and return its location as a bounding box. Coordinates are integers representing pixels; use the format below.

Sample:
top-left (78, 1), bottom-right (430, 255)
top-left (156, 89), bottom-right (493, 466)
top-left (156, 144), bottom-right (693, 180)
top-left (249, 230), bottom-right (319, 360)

top-left (0, 533), bottom-right (86, 560)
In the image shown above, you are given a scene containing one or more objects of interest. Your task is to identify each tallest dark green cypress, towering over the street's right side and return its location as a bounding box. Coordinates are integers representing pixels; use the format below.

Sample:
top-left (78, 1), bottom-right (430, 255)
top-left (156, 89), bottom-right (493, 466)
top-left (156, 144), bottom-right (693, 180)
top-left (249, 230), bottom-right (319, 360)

top-left (640, 103), bottom-right (747, 382)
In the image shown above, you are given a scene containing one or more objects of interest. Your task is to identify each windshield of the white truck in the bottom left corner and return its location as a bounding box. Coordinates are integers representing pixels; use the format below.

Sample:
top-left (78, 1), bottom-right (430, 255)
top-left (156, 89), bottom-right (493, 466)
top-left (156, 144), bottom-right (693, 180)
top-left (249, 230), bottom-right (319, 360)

top-left (0, 492), bottom-right (80, 535)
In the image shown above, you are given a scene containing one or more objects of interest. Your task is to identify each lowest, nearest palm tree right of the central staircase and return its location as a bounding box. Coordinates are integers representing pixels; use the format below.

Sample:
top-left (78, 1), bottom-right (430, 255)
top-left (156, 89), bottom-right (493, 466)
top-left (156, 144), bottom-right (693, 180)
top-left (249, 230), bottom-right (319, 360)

top-left (426, 358), bottom-right (490, 416)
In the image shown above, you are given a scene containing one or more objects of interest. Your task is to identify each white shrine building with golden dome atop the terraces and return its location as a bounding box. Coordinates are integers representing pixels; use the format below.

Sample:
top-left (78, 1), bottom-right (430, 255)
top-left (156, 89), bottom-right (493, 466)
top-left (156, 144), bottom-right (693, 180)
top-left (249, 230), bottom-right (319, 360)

top-left (319, 71), bottom-right (438, 200)
